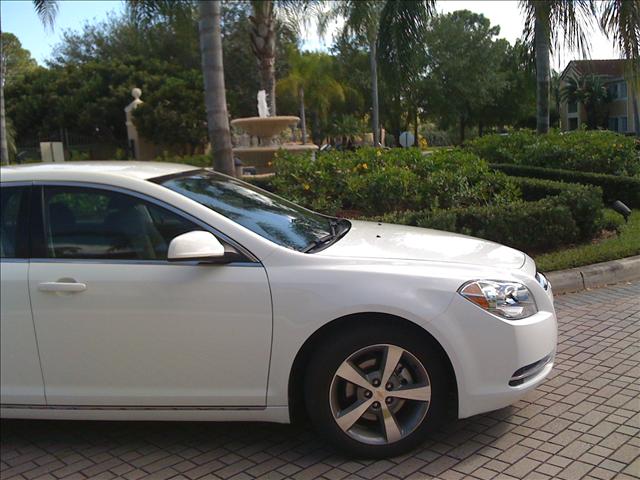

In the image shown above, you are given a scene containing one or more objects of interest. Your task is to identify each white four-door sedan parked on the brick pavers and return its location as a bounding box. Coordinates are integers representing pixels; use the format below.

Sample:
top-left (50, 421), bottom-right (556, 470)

top-left (0, 162), bottom-right (557, 457)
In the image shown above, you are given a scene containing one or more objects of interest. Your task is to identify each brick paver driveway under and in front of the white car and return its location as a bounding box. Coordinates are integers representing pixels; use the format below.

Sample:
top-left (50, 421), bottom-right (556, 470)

top-left (0, 283), bottom-right (640, 480)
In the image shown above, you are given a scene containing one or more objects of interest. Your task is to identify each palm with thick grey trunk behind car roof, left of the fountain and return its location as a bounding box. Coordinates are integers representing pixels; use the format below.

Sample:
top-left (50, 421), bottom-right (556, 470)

top-left (128, 0), bottom-right (235, 175)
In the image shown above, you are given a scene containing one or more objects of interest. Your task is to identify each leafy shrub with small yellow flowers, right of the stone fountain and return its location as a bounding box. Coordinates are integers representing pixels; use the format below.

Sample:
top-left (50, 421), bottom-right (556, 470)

top-left (271, 148), bottom-right (519, 215)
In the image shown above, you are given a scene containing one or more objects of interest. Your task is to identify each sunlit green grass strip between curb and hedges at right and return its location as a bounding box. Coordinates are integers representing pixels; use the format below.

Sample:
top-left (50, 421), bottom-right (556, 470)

top-left (535, 211), bottom-right (640, 272)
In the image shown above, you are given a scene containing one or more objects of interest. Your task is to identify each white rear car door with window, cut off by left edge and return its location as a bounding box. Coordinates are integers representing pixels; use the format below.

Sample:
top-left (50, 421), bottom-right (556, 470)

top-left (0, 185), bottom-right (45, 406)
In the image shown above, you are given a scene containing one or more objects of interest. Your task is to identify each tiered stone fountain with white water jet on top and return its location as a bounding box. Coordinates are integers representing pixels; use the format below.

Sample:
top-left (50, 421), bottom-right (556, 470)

top-left (231, 90), bottom-right (318, 174)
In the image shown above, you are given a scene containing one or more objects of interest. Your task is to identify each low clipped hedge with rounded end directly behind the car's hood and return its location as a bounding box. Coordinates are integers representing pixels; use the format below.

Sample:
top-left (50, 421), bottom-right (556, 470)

top-left (375, 178), bottom-right (609, 253)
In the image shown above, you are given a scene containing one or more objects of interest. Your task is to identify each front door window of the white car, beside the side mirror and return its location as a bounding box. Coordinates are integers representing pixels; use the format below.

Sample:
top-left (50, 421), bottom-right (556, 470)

top-left (43, 186), bottom-right (202, 260)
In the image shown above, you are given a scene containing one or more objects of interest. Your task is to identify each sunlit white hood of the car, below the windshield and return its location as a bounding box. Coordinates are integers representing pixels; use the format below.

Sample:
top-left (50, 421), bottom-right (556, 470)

top-left (317, 220), bottom-right (526, 269)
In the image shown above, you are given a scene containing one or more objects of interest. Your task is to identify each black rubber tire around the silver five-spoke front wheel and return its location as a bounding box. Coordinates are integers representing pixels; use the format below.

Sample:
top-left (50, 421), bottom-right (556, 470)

top-left (304, 321), bottom-right (452, 458)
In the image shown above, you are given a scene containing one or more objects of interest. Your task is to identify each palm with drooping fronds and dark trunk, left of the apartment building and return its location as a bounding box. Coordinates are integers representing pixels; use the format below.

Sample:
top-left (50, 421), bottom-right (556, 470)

top-left (520, 0), bottom-right (595, 133)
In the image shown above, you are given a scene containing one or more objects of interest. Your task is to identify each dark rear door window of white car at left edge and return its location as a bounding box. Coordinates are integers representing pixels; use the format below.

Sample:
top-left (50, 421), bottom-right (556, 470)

top-left (0, 187), bottom-right (29, 258)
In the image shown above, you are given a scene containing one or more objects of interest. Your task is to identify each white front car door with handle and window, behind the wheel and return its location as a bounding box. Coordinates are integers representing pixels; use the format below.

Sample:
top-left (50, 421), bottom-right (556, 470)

top-left (29, 185), bottom-right (272, 406)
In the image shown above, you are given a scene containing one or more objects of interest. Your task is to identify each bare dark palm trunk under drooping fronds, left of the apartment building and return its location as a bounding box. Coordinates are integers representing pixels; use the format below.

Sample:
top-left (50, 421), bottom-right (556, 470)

top-left (534, 7), bottom-right (551, 133)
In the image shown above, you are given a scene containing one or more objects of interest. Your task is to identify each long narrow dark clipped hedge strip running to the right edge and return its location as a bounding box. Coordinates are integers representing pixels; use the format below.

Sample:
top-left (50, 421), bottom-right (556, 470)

top-left (490, 163), bottom-right (640, 207)
